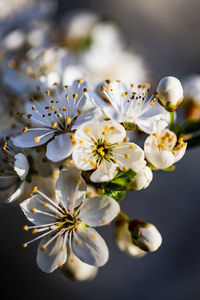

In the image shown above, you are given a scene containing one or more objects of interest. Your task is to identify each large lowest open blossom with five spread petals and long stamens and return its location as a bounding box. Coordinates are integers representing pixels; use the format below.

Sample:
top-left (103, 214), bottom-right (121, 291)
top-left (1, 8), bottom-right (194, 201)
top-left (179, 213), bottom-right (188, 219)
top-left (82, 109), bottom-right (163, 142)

top-left (20, 167), bottom-right (120, 273)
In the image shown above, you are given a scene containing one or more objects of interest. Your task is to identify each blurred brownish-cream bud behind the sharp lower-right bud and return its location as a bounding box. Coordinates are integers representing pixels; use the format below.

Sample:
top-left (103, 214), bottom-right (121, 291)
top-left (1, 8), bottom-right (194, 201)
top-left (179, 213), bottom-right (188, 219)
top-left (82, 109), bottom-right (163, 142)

top-left (115, 221), bottom-right (146, 258)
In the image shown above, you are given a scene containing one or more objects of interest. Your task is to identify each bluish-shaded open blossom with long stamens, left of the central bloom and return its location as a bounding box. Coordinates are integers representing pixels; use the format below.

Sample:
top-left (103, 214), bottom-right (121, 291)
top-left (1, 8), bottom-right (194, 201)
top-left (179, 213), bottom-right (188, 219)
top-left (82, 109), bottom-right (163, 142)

top-left (13, 80), bottom-right (101, 162)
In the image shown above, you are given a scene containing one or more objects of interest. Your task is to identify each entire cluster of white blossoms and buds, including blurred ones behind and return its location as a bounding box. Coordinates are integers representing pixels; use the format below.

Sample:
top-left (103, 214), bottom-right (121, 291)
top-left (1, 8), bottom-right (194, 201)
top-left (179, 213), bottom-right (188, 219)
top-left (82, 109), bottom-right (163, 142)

top-left (0, 0), bottom-right (197, 281)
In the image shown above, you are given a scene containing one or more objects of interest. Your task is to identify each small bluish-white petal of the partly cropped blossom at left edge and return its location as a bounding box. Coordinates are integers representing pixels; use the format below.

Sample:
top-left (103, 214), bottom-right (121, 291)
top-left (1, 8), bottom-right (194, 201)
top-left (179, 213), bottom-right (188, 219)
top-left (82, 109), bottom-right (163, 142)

top-left (14, 153), bottom-right (29, 180)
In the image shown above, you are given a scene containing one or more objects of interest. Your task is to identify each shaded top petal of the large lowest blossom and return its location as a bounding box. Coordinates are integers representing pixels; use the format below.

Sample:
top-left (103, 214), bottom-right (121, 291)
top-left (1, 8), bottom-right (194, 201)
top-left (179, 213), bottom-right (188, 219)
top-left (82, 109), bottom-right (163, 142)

top-left (56, 167), bottom-right (87, 210)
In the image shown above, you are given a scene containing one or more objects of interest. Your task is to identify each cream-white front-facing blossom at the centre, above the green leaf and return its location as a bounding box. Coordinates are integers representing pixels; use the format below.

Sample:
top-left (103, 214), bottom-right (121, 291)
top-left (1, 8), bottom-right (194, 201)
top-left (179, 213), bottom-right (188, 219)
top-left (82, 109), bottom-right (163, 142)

top-left (72, 121), bottom-right (146, 182)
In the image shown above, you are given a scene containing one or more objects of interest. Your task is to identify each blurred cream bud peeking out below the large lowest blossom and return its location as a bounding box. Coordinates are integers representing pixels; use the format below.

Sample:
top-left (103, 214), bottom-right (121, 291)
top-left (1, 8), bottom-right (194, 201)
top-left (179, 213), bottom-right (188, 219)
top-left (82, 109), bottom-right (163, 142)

top-left (61, 252), bottom-right (98, 281)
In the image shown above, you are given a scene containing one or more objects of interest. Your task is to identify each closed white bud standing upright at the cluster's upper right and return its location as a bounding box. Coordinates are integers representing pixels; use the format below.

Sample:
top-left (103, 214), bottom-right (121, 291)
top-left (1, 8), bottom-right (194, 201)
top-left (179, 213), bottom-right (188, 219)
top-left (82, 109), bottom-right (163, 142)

top-left (157, 76), bottom-right (183, 112)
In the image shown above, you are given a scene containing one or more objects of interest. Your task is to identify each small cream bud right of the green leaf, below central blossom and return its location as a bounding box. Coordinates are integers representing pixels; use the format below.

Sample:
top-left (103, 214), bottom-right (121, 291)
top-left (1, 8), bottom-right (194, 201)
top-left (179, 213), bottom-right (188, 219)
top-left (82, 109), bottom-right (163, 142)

top-left (130, 167), bottom-right (153, 191)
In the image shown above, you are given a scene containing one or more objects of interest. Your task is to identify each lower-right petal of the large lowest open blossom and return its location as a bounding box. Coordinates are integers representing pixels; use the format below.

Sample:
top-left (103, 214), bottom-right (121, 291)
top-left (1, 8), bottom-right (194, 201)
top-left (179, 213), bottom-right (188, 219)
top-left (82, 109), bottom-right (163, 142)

top-left (72, 228), bottom-right (109, 267)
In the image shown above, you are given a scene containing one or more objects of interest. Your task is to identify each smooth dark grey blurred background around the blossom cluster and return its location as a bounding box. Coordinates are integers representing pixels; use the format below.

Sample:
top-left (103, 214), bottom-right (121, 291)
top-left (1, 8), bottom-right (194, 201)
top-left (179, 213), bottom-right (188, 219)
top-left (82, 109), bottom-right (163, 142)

top-left (0, 0), bottom-right (200, 300)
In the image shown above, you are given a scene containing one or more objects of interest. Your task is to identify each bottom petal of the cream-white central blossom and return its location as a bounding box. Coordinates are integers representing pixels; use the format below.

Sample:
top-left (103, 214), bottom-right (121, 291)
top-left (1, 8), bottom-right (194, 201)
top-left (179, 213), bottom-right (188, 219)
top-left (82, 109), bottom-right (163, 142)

top-left (90, 159), bottom-right (117, 182)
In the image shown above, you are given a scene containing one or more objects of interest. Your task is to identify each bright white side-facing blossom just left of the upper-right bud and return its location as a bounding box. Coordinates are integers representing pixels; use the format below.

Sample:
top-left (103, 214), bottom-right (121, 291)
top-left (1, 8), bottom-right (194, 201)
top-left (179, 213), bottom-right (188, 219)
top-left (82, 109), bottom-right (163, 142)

top-left (94, 80), bottom-right (169, 134)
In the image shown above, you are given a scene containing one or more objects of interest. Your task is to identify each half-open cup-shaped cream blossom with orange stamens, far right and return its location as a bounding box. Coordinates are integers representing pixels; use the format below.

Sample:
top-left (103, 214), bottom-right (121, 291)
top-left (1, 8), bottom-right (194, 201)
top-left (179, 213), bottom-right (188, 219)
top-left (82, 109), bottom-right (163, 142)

top-left (144, 129), bottom-right (187, 169)
